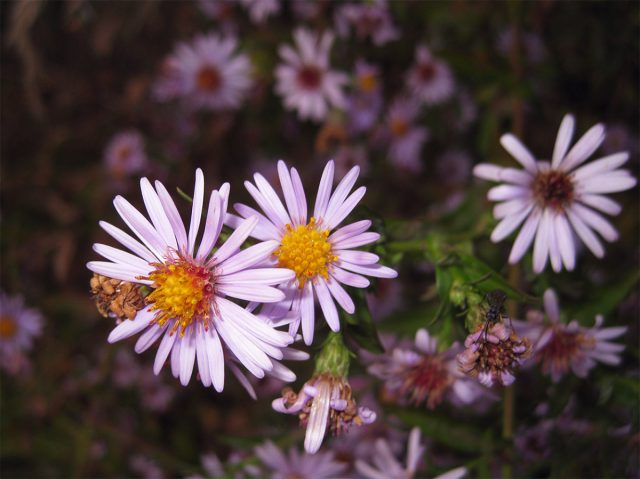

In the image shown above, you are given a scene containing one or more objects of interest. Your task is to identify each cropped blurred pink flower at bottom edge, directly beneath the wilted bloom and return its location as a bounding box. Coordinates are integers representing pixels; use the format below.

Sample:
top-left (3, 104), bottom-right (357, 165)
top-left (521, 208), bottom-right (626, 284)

top-left (255, 441), bottom-right (347, 479)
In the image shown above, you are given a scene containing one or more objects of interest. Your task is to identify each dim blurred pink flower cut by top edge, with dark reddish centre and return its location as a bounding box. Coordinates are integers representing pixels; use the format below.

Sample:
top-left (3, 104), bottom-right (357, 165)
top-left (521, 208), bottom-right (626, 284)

top-left (335, 0), bottom-right (400, 46)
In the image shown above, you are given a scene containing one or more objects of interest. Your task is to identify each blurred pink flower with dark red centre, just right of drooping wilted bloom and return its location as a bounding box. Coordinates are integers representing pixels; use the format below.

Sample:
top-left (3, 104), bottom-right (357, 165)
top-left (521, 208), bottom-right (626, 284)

top-left (368, 329), bottom-right (483, 409)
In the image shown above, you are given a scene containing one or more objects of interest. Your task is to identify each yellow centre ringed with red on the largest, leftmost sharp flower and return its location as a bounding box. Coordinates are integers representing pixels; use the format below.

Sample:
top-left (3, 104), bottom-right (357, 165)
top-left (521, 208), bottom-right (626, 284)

top-left (143, 256), bottom-right (216, 336)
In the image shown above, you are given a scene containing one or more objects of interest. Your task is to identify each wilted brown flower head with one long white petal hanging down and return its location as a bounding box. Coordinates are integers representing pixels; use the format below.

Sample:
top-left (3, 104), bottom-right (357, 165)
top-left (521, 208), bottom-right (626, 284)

top-left (271, 373), bottom-right (376, 454)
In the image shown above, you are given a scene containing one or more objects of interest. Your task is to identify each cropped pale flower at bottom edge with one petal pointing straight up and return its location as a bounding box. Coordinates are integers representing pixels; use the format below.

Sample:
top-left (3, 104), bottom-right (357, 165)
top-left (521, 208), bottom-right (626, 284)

top-left (356, 427), bottom-right (467, 479)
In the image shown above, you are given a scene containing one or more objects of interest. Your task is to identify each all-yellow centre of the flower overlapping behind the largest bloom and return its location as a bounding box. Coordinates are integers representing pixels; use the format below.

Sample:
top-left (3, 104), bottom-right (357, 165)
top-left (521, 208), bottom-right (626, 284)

top-left (273, 217), bottom-right (338, 289)
